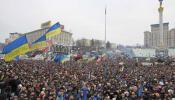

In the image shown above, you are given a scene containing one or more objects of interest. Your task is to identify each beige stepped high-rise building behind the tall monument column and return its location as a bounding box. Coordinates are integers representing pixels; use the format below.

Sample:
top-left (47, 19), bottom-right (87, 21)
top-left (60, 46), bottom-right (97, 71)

top-left (144, 23), bottom-right (175, 48)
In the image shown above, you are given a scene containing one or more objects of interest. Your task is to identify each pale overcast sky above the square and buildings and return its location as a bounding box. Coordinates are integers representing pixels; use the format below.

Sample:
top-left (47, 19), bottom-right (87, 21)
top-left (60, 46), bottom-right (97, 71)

top-left (0, 0), bottom-right (175, 45)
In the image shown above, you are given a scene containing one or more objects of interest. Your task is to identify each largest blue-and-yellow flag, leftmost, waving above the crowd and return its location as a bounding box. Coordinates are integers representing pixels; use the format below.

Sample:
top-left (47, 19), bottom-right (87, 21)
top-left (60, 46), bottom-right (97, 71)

top-left (3, 35), bottom-right (29, 61)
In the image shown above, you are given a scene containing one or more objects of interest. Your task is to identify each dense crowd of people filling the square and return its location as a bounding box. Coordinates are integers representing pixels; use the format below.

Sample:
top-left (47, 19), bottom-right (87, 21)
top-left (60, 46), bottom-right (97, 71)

top-left (0, 57), bottom-right (175, 100)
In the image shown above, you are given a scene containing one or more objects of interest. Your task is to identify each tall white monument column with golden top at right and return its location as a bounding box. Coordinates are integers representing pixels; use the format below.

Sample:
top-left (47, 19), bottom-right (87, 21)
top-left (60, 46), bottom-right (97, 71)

top-left (158, 0), bottom-right (165, 48)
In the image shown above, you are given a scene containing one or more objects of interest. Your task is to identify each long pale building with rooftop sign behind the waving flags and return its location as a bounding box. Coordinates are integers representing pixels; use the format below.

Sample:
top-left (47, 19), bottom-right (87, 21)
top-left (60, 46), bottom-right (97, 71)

top-left (5, 21), bottom-right (73, 46)
